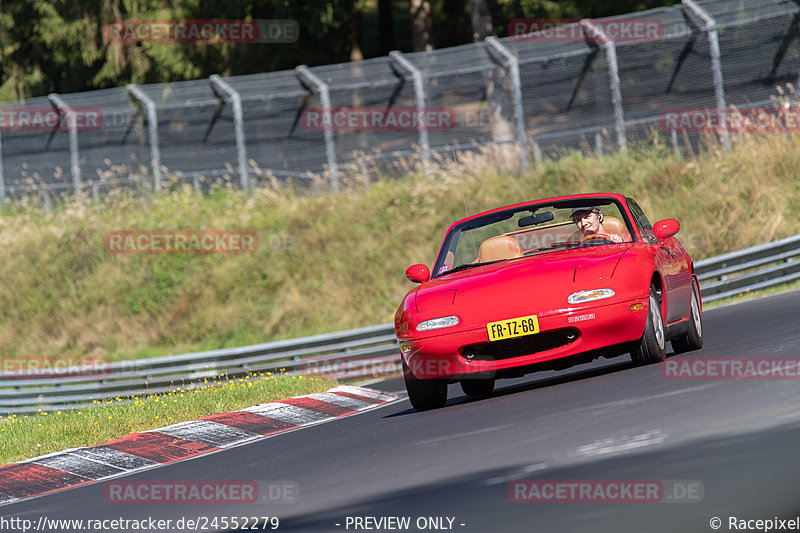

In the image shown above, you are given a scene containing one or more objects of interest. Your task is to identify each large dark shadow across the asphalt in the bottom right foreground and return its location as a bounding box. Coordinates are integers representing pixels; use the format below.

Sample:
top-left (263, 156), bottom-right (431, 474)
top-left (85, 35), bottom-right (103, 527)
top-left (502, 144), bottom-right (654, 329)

top-left (239, 425), bottom-right (800, 533)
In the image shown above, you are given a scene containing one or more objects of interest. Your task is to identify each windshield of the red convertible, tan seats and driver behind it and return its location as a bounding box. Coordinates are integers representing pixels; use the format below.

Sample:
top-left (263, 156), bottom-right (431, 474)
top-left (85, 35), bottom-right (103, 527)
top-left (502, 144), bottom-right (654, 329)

top-left (434, 198), bottom-right (632, 276)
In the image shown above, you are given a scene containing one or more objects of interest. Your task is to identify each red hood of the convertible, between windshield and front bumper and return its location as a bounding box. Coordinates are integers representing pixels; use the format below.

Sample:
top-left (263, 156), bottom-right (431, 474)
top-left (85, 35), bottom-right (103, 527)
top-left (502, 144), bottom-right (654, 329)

top-left (415, 243), bottom-right (632, 327)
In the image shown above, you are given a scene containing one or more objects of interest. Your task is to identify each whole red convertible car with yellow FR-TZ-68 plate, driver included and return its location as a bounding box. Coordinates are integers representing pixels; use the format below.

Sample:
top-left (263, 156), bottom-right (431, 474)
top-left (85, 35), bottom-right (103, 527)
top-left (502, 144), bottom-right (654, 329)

top-left (395, 194), bottom-right (703, 410)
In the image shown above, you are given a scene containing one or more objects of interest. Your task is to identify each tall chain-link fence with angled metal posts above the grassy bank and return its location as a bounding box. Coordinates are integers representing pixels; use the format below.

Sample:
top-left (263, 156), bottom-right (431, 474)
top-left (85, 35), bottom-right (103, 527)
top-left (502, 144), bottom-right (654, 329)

top-left (0, 0), bottom-right (800, 203)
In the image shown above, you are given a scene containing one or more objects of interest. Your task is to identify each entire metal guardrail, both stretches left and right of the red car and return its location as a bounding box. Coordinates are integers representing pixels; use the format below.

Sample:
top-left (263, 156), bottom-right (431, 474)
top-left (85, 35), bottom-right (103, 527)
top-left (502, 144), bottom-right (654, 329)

top-left (0, 235), bottom-right (800, 414)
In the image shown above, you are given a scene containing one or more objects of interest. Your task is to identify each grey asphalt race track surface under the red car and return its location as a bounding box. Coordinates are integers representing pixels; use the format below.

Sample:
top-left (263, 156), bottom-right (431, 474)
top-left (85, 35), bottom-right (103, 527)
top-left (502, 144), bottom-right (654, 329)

top-left (0, 291), bottom-right (800, 533)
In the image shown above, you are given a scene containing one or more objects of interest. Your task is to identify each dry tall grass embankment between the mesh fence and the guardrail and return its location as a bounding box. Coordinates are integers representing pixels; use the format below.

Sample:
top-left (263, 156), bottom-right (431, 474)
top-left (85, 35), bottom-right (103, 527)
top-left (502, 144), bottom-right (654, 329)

top-left (0, 127), bottom-right (800, 358)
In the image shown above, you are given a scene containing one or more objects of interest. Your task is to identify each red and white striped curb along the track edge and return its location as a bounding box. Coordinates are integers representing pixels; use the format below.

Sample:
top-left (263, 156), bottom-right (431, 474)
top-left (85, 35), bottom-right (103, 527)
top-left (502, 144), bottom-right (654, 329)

top-left (0, 385), bottom-right (400, 505)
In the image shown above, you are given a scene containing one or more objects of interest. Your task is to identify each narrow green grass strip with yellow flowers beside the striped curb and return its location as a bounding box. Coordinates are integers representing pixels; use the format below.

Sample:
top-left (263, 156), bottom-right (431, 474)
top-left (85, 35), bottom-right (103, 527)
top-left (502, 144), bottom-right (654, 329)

top-left (0, 374), bottom-right (336, 465)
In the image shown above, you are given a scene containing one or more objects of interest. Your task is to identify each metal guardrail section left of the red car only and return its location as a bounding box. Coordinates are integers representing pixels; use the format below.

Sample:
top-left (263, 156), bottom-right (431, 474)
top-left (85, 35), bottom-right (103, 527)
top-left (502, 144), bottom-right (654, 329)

top-left (0, 324), bottom-right (399, 414)
